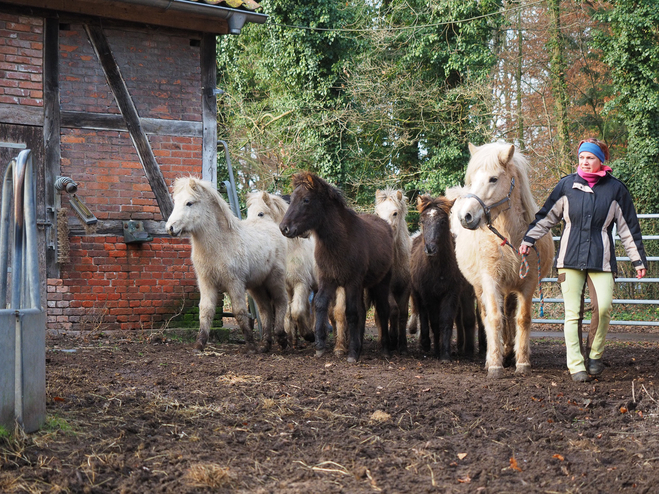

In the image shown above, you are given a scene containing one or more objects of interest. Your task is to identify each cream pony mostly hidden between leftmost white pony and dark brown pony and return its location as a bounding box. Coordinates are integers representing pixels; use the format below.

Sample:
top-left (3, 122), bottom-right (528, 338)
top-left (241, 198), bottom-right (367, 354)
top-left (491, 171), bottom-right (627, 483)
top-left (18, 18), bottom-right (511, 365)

top-left (247, 191), bottom-right (318, 347)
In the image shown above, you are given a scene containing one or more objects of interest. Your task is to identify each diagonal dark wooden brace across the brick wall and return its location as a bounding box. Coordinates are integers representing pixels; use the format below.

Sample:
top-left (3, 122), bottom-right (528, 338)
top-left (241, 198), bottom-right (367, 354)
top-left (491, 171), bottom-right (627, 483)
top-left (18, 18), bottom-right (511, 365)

top-left (85, 24), bottom-right (174, 219)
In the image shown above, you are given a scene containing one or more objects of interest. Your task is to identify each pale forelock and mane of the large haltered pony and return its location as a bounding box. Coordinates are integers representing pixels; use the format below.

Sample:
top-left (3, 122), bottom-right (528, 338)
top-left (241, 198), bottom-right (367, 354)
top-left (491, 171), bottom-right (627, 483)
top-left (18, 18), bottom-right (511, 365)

top-left (465, 141), bottom-right (538, 224)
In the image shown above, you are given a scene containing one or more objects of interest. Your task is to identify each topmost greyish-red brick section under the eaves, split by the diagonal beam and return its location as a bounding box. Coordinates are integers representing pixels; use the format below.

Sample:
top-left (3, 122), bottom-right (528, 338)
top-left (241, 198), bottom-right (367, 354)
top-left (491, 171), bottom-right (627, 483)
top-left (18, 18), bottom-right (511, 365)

top-left (60, 24), bottom-right (201, 122)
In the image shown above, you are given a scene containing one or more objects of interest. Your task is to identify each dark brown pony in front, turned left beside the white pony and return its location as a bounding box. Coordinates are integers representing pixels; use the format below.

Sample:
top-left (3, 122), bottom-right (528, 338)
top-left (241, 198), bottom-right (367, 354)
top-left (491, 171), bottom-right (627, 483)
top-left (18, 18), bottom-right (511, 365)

top-left (279, 172), bottom-right (393, 362)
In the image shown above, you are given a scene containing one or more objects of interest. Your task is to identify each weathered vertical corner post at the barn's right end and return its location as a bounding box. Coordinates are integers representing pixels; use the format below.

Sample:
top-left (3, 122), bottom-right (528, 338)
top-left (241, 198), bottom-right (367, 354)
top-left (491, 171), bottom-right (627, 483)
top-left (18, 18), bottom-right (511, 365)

top-left (199, 34), bottom-right (217, 188)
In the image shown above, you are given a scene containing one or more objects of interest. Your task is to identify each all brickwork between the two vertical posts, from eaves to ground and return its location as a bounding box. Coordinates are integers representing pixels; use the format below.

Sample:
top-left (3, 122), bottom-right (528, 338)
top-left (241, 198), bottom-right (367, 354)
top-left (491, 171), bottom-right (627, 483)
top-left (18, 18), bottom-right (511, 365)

top-left (47, 25), bottom-right (202, 331)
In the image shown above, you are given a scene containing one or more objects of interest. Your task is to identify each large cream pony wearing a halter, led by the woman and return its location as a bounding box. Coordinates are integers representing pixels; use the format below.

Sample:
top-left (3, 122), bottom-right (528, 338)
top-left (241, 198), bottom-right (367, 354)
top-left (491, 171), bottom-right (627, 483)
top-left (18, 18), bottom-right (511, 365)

top-left (447, 142), bottom-right (554, 378)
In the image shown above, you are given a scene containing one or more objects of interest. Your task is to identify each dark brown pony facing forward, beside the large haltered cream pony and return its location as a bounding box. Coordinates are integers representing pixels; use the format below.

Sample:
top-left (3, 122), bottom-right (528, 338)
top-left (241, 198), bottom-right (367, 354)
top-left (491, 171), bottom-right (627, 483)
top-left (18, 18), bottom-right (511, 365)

top-left (411, 195), bottom-right (476, 361)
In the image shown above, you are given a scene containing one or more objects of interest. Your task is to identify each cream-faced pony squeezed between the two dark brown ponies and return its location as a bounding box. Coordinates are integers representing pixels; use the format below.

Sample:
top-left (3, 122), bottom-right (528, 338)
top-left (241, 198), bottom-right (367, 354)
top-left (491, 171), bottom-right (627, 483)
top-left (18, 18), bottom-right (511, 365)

top-left (375, 188), bottom-right (412, 353)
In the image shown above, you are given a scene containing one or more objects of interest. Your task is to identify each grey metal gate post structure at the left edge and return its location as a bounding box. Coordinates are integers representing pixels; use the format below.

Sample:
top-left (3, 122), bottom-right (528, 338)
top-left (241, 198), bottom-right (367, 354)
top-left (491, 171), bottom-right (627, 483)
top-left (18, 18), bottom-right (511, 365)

top-left (0, 149), bottom-right (46, 432)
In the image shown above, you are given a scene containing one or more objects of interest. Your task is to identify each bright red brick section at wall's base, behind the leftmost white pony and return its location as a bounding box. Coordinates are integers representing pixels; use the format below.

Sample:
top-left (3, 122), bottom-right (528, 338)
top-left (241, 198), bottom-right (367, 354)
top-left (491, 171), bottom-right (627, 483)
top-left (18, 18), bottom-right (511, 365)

top-left (47, 235), bottom-right (198, 331)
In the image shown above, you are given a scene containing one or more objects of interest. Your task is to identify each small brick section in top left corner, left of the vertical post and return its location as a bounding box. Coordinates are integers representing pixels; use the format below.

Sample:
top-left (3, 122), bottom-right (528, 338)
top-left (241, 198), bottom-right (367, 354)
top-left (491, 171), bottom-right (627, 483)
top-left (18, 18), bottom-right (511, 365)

top-left (0, 13), bottom-right (43, 106)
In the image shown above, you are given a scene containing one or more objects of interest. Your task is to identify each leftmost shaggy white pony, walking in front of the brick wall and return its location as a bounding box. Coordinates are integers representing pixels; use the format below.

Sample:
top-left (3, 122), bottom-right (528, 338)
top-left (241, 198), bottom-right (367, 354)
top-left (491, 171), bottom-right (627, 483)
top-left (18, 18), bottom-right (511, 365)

top-left (167, 177), bottom-right (287, 351)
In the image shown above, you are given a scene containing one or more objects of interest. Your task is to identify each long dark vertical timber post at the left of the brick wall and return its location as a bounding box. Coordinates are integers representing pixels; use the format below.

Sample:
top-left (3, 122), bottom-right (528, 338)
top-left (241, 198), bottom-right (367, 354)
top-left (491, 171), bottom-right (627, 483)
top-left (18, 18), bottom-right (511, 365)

top-left (43, 17), bottom-right (61, 278)
